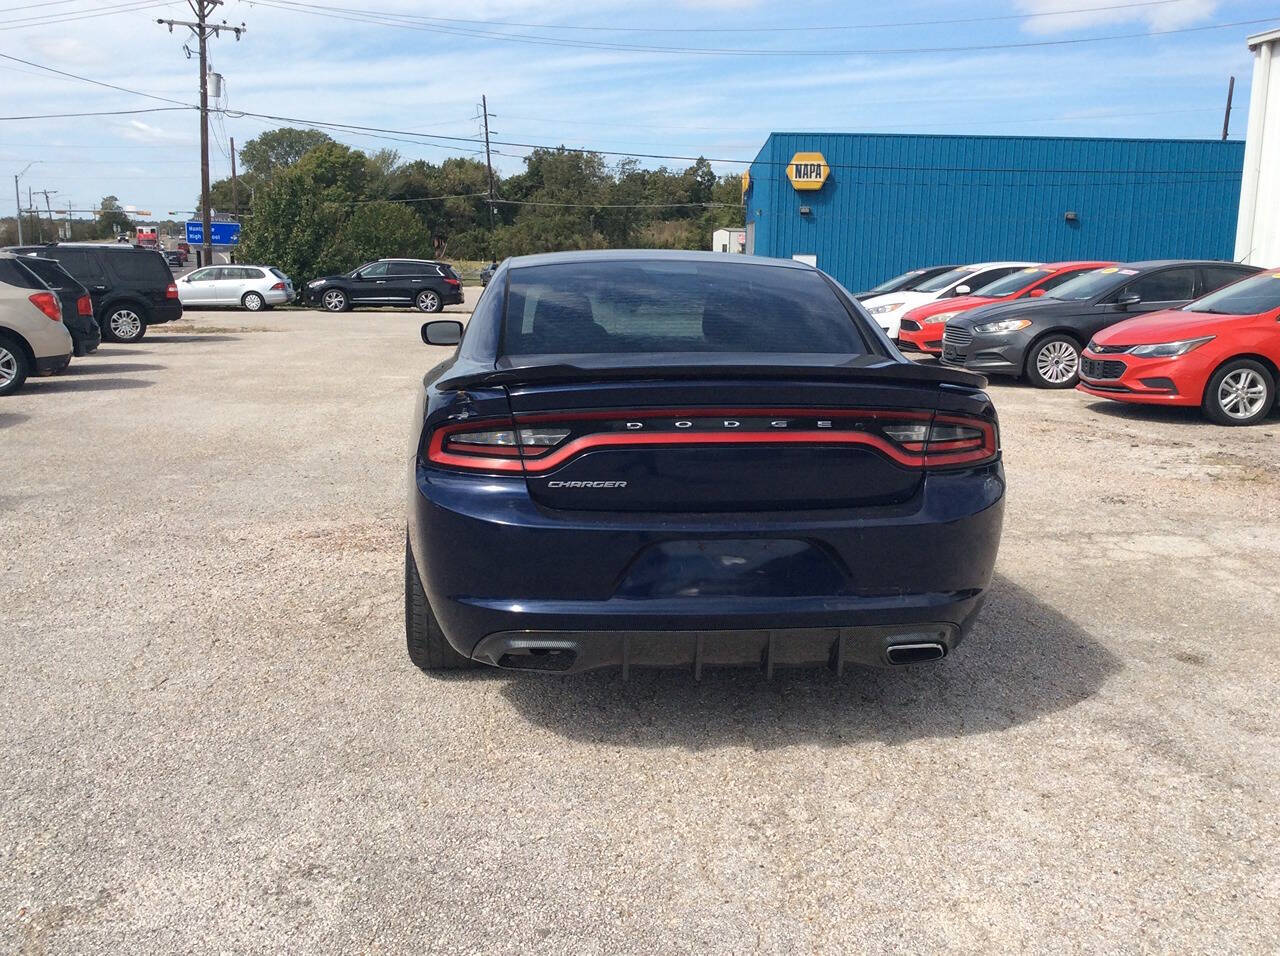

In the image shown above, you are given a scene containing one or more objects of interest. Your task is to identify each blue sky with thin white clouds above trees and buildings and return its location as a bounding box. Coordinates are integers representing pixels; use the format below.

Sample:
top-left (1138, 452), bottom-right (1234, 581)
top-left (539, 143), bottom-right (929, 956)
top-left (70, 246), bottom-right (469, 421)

top-left (0, 0), bottom-right (1280, 219)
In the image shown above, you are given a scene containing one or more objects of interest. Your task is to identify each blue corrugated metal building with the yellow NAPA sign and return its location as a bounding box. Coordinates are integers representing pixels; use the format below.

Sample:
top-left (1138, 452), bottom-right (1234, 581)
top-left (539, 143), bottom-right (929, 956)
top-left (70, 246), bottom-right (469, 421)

top-left (744, 133), bottom-right (1244, 291)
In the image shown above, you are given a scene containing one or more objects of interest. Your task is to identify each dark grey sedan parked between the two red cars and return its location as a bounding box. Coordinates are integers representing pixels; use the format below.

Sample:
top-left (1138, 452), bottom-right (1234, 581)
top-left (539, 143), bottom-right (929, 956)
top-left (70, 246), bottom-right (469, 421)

top-left (942, 260), bottom-right (1258, 388)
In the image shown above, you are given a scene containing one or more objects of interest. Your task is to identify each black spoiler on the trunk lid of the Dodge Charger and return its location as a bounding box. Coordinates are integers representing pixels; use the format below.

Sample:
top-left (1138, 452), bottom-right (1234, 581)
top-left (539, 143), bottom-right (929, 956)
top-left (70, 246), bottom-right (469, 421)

top-left (436, 356), bottom-right (987, 392)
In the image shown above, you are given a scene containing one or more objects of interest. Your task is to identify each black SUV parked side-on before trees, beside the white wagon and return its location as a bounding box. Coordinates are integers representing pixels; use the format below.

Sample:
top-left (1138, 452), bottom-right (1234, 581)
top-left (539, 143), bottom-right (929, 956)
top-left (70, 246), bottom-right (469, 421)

top-left (303, 259), bottom-right (462, 312)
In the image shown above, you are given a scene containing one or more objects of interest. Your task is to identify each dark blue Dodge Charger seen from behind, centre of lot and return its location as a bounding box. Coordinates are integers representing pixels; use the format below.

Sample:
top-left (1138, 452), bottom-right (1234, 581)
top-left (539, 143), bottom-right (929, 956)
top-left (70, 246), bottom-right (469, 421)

top-left (404, 251), bottom-right (1005, 676)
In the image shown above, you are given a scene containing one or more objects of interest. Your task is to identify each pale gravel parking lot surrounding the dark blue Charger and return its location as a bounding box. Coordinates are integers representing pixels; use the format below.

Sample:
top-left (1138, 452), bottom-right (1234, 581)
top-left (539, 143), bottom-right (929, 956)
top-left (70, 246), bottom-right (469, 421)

top-left (0, 295), bottom-right (1280, 953)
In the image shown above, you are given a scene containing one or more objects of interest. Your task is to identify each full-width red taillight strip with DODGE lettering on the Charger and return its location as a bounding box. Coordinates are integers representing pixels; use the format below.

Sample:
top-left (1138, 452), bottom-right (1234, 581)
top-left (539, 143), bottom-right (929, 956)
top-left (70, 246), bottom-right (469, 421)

top-left (426, 408), bottom-right (1000, 475)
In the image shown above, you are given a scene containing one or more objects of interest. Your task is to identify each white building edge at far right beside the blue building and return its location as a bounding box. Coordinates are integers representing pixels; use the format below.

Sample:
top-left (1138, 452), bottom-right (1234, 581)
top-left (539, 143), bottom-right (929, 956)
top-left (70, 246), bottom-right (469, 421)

top-left (1235, 29), bottom-right (1280, 267)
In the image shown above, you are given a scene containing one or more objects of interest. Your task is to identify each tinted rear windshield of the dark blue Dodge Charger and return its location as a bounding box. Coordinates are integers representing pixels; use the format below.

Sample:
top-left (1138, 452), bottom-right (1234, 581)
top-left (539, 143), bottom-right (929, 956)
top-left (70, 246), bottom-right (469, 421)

top-left (502, 260), bottom-right (867, 356)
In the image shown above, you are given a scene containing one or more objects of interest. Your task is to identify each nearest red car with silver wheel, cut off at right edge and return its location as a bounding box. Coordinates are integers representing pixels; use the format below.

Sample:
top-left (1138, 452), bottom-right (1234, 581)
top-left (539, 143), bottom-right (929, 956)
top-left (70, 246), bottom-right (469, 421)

top-left (1076, 264), bottom-right (1280, 425)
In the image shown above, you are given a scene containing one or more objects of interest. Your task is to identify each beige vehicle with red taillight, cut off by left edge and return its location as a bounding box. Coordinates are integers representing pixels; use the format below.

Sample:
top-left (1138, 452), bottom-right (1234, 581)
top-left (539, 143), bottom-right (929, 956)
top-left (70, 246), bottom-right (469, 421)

top-left (0, 252), bottom-right (73, 395)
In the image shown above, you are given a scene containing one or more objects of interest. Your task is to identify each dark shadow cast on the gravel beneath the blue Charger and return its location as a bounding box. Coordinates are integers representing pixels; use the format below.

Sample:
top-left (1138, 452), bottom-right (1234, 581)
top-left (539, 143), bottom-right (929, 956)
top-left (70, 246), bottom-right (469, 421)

top-left (499, 577), bottom-right (1121, 750)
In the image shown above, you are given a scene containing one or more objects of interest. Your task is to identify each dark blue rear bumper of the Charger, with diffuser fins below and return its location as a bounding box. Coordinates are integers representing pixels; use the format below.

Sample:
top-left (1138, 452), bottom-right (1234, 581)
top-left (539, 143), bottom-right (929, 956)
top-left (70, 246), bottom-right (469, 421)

top-left (410, 463), bottom-right (1005, 671)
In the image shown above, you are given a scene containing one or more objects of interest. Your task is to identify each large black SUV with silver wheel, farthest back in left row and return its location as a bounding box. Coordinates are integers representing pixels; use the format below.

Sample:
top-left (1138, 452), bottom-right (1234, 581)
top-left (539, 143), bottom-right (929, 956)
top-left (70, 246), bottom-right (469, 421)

top-left (12, 242), bottom-right (182, 342)
